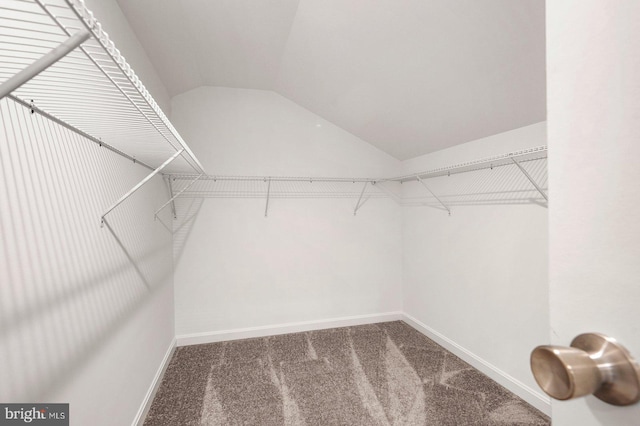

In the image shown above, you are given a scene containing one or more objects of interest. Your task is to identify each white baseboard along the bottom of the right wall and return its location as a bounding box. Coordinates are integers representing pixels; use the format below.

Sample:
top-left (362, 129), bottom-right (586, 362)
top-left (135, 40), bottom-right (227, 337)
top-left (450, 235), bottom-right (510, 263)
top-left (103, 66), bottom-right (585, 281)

top-left (402, 313), bottom-right (551, 416)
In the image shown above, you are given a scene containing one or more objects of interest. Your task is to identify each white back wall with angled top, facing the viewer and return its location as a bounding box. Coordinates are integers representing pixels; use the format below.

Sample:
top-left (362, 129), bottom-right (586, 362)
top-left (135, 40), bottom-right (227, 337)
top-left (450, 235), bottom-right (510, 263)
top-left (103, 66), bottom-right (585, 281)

top-left (172, 87), bottom-right (402, 336)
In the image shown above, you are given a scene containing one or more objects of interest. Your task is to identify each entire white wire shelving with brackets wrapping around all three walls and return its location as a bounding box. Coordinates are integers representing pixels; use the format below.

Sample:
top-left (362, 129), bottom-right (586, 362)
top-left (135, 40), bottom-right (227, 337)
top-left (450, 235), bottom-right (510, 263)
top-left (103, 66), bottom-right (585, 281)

top-left (0, 0), bottom-right (547, 222)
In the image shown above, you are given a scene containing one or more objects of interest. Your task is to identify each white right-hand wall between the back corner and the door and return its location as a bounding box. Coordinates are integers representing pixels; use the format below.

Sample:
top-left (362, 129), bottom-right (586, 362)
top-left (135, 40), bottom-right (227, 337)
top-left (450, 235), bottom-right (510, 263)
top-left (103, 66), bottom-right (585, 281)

top-left (403, 123), bottom-right (549, 407)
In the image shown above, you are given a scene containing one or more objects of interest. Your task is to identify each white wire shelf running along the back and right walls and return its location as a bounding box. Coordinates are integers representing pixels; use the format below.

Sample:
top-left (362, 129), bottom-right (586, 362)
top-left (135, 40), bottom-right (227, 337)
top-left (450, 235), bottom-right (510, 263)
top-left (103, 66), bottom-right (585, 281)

top-left (168, 146), bottom-right (547, 206)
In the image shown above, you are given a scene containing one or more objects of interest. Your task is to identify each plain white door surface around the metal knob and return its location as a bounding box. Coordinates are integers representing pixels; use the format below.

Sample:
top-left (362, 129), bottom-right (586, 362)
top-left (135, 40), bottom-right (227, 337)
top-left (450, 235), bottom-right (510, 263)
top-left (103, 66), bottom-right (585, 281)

top-left (547, 0), bottom-right (640, 426)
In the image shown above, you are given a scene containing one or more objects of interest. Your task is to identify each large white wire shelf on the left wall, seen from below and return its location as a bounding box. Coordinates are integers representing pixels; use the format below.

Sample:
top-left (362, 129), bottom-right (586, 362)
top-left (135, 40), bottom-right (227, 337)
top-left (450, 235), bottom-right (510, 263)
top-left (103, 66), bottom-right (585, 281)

top-left (0, 0), bottom-right (203, 173)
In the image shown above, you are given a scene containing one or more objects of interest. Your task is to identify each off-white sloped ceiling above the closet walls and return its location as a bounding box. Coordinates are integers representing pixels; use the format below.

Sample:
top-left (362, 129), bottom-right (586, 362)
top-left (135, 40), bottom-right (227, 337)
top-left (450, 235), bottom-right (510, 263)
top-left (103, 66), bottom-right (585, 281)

top-left (118, 0), bottom-right (546, 160)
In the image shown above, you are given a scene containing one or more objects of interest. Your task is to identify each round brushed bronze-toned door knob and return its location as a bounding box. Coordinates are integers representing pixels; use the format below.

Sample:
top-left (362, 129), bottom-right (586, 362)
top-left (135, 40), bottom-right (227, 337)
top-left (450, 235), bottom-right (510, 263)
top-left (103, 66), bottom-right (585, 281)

top-left (531, 333), bottom-right (640, 405)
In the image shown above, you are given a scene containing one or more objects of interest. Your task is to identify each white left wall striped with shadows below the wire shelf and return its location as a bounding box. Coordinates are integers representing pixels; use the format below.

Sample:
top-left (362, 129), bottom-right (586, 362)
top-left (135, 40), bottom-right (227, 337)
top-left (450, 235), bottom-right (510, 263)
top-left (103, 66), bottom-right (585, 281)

top-left (0, 96), bottom-right (174, 425)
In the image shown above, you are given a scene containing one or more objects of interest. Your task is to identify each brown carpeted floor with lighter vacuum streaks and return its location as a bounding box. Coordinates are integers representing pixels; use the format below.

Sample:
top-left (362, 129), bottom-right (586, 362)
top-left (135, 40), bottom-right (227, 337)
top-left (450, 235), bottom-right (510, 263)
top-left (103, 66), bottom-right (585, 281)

top-left (144, 321), bottom-right (550, 426)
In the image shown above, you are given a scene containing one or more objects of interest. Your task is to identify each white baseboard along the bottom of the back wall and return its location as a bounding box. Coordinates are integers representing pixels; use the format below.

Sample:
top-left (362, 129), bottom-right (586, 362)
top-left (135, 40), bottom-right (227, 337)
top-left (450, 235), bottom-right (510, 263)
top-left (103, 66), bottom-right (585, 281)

top-left (176, 311), bottom-right (403, 346)
